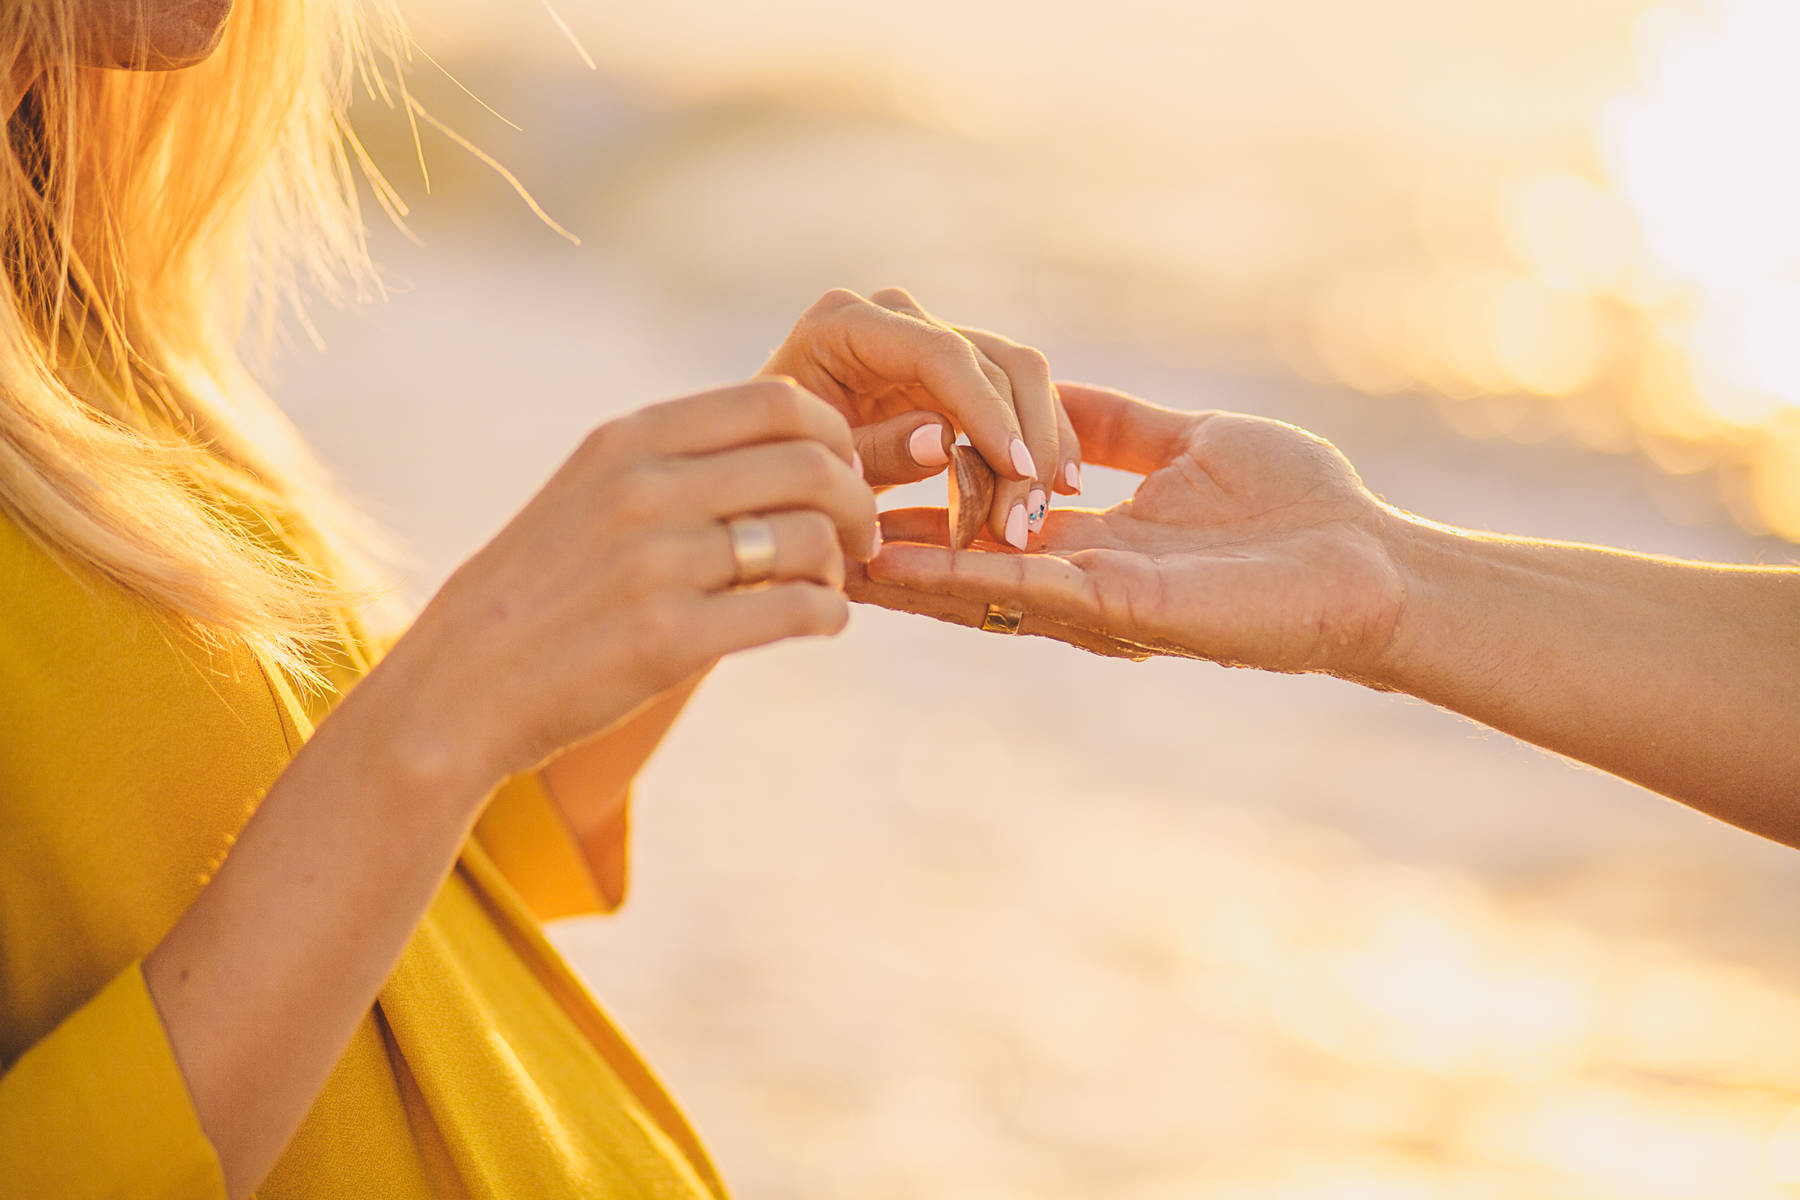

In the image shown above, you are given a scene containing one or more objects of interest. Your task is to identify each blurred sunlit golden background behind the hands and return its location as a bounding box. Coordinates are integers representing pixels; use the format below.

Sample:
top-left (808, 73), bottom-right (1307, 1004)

top-left (274, 0), bottom-right (1800, 1200)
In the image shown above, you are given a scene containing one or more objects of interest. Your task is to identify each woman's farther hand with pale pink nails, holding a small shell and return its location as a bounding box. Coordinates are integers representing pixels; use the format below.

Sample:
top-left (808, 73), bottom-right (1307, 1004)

top-left (761, 288), bottom-right (1082, 551)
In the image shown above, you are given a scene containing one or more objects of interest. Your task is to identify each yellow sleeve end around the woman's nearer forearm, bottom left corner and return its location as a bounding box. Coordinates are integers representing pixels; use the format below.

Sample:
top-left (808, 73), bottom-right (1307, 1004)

top-left (0, 963), bottom-right (225, 1200)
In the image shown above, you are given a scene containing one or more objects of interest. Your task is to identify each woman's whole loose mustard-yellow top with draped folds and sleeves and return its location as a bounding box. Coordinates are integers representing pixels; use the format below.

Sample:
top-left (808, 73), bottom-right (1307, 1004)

top-left (0, 518), bottom-right (724, 1200)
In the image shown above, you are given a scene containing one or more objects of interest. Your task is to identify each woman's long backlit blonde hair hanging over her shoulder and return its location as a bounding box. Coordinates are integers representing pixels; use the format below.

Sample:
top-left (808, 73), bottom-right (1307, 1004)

top-left (0, 0), bottom-right (405, 682)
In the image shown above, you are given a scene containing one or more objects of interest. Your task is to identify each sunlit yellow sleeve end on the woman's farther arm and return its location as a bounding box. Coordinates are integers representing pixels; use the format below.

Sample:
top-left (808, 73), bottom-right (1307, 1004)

top-left (475, 772), bottom-right (626, 921)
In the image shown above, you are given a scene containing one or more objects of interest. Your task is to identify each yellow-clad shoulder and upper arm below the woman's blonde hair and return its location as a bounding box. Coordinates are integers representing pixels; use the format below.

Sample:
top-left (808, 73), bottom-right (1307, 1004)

top-left (0, 503), bottom-right (295, 1060)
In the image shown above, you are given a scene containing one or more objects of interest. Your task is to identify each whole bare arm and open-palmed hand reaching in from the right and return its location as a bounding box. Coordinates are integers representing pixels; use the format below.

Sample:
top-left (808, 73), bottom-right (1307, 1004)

top-left (850, 383), bottom-right (1800, 834)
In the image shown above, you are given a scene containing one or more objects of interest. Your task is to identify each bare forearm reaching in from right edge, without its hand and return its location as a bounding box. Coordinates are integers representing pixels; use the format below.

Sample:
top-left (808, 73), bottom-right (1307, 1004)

top-left (1373, 520), bottom-right (1800, 834)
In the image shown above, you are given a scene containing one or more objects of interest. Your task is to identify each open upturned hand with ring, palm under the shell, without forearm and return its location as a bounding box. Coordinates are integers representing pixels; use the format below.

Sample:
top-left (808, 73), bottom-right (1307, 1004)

top-left (851, 383), bottom-right (1402, 676)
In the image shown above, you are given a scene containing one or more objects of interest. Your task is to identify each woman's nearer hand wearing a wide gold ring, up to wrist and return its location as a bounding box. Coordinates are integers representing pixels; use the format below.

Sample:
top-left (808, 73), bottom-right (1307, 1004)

top-left (383, 378), bottom-right (878, 795)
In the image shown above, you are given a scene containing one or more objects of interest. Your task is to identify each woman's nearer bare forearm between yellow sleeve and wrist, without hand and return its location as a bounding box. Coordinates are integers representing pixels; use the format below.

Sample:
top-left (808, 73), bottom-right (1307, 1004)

top-left (144, 658), bottom-right (499, 1196)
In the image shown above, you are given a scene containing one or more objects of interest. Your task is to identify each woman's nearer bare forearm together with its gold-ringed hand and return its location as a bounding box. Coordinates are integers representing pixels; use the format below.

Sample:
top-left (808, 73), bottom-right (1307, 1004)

top-left (130, 380), bottom-right (875, 1196)
